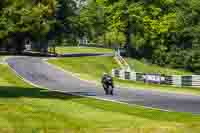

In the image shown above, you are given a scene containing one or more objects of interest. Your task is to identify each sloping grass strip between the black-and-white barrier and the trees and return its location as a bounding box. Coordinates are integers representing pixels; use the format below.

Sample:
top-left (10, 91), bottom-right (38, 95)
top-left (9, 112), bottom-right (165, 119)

top-left (126, 58), bottom-right (192, 75)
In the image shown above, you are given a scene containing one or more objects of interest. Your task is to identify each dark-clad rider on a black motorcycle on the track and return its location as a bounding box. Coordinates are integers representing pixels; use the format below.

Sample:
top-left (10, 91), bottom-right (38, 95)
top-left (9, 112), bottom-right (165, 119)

top-left (101, 73), bottom-right (114, 95)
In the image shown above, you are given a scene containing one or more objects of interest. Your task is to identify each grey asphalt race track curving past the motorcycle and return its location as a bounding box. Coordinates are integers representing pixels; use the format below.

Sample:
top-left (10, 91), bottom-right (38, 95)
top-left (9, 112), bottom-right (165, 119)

top-left (7, 57), bottom-right (200, 114)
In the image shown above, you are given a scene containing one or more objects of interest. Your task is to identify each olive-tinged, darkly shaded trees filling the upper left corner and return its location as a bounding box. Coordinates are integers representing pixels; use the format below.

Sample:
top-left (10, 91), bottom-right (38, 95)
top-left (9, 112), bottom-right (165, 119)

top-left (0, 0), bottom-right (77, 52)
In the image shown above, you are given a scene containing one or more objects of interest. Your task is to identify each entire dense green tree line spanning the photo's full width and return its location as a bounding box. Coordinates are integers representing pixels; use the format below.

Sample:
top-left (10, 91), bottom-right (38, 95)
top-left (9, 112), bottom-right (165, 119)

top-left (0, 0), bottom-right (200, 72)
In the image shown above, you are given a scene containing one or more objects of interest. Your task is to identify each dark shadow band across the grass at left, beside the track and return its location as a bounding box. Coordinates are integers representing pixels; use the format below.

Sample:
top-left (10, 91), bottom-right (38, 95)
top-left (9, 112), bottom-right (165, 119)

top-left (0, 86), bottom-right (81, 100)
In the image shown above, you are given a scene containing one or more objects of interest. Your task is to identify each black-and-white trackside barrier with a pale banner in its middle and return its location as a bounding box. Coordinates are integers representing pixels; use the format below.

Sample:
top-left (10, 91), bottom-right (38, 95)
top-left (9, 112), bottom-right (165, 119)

top-left (112, 69), bottom-right (200, 87)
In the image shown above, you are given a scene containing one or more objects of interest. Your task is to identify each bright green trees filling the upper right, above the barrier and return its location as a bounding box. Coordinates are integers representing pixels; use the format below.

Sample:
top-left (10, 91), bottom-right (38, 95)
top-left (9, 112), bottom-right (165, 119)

top-left (80, 0), bottom-right (200, 72)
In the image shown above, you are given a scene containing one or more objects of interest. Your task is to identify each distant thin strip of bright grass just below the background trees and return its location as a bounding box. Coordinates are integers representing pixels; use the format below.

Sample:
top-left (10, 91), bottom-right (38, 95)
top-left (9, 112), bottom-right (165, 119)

top-left (56, 47), bottom-right (113, 54)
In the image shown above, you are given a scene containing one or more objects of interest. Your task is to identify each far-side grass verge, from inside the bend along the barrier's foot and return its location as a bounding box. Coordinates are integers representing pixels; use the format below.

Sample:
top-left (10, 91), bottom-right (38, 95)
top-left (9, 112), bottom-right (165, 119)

top-left (48, 57), bottom-right (200, 95)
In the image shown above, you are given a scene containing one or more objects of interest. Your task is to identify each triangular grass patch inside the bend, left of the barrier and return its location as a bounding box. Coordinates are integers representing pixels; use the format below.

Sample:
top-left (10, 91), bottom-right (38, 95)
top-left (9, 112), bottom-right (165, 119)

top-left (49, 56), bottom-right (119, 80)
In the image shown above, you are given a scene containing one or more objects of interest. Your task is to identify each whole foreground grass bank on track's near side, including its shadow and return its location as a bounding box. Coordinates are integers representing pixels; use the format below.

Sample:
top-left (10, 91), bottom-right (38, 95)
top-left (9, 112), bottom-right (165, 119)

top-left (0, 57), bottom-right (200, 133)
